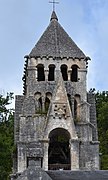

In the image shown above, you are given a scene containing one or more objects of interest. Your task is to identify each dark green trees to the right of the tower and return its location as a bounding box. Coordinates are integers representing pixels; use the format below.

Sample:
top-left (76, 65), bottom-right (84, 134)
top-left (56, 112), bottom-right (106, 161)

top-left (96, 91), bottom-right (108, 169)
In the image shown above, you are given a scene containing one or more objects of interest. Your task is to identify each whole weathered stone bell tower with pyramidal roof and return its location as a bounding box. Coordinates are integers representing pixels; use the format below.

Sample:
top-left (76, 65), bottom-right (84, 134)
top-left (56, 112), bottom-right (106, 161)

top-left (11, 11), bottom-right (99, 179)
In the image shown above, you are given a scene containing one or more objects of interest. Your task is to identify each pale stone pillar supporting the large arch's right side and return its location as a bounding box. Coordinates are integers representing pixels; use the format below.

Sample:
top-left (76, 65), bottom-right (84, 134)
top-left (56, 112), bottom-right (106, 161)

top-left (70, 139), bottom-right (79, 170)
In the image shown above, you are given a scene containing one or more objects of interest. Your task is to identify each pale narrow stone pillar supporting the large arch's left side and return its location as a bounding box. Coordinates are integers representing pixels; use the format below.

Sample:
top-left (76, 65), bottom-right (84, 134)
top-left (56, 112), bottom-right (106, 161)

top-left (43, 139), bottom-right (49, 171)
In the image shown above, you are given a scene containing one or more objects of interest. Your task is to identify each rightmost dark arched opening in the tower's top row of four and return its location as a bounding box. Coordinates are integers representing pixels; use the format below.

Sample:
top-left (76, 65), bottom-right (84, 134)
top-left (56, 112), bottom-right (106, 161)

top-left (71, 65), bottom-right (78, 82)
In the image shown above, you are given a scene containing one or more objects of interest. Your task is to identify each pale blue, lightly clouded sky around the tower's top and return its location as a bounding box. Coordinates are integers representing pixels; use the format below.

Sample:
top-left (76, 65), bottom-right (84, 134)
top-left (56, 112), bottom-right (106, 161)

top-left (0, 0), bottom-right (108, 105)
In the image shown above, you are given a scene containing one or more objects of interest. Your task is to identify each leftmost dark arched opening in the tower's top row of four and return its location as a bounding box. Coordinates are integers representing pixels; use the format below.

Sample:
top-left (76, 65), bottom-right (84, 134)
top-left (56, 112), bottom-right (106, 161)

top-left (37, 64), bottom-right (45, 81)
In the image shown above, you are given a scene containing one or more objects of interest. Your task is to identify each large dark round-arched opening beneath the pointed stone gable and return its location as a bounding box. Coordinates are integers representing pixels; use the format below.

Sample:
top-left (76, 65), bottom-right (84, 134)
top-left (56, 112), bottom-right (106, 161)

top-left (48, 128), bottom-right (71, 170)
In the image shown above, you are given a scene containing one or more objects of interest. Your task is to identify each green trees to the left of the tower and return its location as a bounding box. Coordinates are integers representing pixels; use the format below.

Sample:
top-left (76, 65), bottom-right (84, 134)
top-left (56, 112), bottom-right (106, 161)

top-left (0, 93), bottom-right (14, 180)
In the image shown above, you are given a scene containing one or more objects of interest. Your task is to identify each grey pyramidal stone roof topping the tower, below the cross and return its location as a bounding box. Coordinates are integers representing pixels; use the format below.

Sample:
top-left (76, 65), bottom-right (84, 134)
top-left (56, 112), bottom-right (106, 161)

top-left (29, 11), bottom-right (85, 58)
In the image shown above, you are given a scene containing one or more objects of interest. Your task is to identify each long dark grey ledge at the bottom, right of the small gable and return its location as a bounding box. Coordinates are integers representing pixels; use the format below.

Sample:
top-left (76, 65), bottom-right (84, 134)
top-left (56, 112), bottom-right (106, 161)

top-left (47, 170), bottom-right (108, 180)
